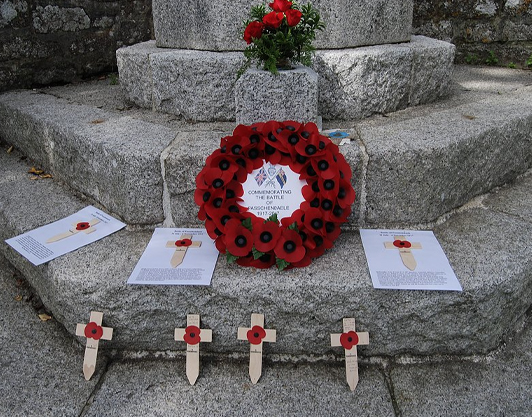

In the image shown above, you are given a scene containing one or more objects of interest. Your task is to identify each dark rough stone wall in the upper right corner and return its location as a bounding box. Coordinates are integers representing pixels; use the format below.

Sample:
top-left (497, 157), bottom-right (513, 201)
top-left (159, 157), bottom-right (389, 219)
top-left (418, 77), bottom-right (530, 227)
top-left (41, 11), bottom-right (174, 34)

top-left (413, 0), bottom-right (532, 67)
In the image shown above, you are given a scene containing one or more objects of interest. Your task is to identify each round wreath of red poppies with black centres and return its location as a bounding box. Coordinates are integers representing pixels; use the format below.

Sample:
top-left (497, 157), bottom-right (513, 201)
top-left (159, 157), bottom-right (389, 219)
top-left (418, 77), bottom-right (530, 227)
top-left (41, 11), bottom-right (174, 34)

top-left (194, 121), bottom-right (355, 270)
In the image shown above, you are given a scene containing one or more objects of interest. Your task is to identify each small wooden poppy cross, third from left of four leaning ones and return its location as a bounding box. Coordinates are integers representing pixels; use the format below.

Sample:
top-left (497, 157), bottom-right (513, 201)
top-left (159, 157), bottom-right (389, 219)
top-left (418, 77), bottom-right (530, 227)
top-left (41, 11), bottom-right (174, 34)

top-left (238, 313), bottom-right (277, 384)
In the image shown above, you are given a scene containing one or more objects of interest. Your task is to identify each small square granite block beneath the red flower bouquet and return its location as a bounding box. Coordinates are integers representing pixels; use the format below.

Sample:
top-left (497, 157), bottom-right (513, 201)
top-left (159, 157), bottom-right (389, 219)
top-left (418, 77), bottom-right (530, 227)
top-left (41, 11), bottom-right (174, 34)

top-left (235, 66), bottom-right (318, 124)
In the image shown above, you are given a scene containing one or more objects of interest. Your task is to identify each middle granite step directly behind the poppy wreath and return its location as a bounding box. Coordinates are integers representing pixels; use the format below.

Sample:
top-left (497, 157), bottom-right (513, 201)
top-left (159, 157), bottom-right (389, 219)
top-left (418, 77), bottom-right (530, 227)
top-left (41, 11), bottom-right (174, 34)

top-left (0, 67), bottom-right (532, 230)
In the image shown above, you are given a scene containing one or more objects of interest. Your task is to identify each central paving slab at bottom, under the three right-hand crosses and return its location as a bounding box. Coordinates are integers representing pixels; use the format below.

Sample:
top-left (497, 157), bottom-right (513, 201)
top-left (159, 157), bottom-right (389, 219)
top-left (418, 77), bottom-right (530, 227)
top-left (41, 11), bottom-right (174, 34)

top-left (84, 359), bottom-right (394, 417)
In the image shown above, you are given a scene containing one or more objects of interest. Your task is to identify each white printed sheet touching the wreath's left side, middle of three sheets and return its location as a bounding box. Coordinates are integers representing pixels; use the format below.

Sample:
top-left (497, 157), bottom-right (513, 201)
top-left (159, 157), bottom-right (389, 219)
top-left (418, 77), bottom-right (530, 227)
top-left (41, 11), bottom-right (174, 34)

top-left (127, 228), bottom-right (219, 285)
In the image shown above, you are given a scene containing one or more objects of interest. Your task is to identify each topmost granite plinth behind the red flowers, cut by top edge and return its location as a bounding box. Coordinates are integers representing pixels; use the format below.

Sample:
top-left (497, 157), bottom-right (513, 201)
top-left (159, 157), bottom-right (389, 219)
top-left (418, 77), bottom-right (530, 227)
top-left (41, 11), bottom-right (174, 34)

top-left (153, 0), bottom-right (413, 51)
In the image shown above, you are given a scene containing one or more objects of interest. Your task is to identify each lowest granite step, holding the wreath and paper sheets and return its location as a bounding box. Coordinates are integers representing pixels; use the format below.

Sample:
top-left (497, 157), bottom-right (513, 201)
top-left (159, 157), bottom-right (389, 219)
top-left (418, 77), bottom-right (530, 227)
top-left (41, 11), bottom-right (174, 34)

top-left (0, 146), bottom-right (532, 361)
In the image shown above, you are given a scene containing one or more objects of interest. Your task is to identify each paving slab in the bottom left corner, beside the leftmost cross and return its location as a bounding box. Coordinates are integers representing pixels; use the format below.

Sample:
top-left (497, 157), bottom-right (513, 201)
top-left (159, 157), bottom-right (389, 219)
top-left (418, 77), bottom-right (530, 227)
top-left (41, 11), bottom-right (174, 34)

top-left (0, 256), bottom-right (100, 417)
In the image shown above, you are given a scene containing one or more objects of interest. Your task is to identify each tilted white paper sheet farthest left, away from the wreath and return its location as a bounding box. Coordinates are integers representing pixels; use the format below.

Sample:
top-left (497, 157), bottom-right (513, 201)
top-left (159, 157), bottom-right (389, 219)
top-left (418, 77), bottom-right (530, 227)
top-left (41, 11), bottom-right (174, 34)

top-left (6, 206), bottom-right (126, 265)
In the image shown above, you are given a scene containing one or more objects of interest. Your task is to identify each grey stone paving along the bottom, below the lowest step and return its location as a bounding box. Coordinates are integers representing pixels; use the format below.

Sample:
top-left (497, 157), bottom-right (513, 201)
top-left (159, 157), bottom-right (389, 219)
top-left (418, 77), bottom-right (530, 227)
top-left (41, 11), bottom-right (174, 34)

top-left (0, 252), bottom-right (532, 417)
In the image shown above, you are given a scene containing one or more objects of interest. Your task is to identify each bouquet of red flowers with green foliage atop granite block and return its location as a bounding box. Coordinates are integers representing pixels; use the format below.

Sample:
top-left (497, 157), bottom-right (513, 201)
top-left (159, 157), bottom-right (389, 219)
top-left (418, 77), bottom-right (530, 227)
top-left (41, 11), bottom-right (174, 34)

top-left (239, 0), bottom-right (325, 75)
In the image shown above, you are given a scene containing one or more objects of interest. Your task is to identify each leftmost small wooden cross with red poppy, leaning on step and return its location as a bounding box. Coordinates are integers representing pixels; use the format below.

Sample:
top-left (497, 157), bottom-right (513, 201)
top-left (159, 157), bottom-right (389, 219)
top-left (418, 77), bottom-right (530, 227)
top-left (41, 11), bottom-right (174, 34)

top-left (76, 311), bottom-right (113, 381)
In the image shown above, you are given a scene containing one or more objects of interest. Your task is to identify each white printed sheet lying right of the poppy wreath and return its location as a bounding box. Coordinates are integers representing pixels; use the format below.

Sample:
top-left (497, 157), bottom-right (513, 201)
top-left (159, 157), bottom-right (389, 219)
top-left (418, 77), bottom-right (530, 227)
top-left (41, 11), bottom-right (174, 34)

top-left (360, 229), bottom-right (462, 291)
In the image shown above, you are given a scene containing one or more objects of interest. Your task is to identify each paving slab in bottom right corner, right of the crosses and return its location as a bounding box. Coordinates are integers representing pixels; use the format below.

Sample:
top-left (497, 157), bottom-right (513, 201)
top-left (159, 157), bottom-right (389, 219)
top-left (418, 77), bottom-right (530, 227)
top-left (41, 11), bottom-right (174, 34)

top-left (391, 316), bottom-right (532, 417)
